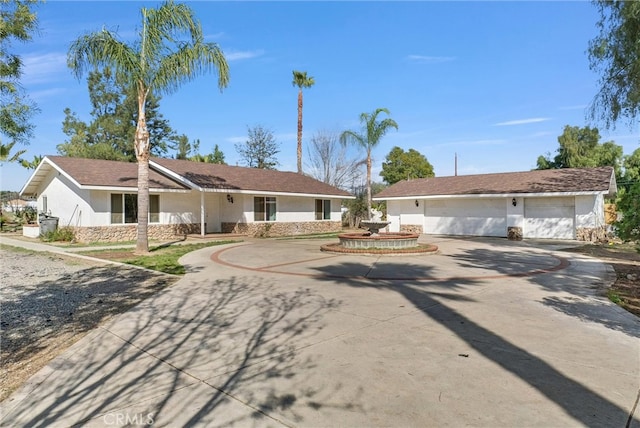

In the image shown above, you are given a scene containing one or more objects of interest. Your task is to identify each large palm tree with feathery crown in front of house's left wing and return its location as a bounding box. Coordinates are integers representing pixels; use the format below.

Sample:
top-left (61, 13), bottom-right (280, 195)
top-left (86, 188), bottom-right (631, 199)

top-left (67, 0), bottom-right (229, 254)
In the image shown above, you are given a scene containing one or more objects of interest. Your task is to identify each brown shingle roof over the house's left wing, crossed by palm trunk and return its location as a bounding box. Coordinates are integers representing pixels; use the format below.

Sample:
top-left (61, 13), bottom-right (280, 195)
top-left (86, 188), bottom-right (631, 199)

top-left (47, 156), bottom-right (188, 190)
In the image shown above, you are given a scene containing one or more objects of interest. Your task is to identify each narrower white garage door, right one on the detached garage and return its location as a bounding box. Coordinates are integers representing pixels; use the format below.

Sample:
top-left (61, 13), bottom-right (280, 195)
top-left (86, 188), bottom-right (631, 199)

top-left (523, 198), bottom-right (575, 239)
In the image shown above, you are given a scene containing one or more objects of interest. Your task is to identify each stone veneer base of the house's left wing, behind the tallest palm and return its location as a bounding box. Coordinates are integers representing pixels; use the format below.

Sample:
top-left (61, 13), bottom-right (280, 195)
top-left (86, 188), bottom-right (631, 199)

top-left (73, 223), bottom-right (200, 242)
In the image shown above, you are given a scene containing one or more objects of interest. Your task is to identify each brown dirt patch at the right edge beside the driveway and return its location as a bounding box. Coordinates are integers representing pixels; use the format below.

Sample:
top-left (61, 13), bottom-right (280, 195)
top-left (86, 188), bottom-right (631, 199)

top-left (566, 244), bottom-right (640, 317)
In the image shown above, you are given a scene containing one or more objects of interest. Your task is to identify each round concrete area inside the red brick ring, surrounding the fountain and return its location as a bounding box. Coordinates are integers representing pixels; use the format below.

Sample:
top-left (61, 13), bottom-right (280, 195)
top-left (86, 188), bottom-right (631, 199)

top-left (211, 234), bottom-right (570, 281)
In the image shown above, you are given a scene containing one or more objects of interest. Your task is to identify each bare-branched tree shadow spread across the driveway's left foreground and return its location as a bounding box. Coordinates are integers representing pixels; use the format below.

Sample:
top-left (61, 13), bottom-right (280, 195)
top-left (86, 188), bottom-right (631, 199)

top-left (1, 277), bottom-right (358, 427)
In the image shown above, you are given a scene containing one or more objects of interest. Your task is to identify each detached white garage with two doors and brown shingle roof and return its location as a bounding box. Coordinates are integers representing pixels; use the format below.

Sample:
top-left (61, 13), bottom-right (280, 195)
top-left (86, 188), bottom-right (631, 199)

top-left (373, 167), bottom-right (617, 240)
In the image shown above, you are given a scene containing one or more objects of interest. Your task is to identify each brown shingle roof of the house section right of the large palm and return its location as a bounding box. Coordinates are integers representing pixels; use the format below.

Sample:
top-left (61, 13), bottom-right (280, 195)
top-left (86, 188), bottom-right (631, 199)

top-left (151, 158), bottom-right (351, 197)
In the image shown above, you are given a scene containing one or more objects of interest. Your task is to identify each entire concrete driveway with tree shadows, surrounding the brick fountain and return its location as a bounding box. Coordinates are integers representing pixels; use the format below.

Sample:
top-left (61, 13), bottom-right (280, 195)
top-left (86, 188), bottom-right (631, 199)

top-left (1, 237), bottom-right (640, 427)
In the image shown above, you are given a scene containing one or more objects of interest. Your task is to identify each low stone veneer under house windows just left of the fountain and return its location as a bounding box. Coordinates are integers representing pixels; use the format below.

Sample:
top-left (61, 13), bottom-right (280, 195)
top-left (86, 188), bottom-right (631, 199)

top-left (222, 221), bottom-right (342, 238)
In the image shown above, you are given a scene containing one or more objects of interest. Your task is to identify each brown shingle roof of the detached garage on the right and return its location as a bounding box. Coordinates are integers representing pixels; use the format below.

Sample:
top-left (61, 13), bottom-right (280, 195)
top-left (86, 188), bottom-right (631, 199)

top-left (375, 166), bottom-right (615, 199)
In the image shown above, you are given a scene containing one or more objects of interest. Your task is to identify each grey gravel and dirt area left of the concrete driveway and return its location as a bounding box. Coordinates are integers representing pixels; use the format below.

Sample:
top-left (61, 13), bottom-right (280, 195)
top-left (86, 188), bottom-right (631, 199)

top-left (0, 246), bottom-right (178, 401)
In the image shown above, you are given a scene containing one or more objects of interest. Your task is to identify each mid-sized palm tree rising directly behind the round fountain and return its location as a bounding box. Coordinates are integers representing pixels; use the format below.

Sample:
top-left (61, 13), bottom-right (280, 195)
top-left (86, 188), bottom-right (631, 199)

top-left (340, 108), bottom-right (398, 218)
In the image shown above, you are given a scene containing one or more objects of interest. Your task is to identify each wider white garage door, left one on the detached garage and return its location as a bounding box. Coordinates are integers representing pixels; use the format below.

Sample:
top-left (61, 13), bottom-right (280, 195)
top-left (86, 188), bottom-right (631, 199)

top-left (424, 199), bottom-right (507, 236)
